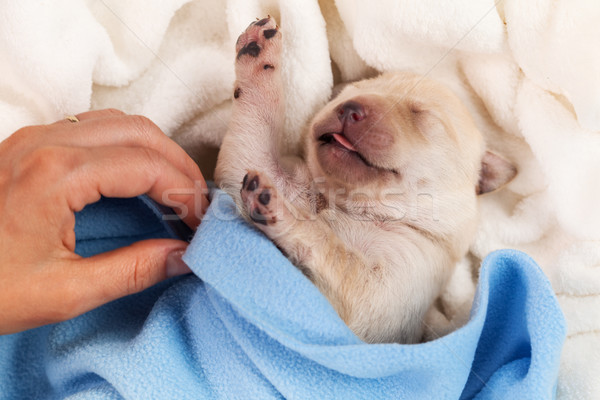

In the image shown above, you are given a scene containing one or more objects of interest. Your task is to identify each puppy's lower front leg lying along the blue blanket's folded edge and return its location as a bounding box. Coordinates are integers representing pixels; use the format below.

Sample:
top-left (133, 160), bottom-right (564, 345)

top-left (241, 171), bottom-right (393, 341)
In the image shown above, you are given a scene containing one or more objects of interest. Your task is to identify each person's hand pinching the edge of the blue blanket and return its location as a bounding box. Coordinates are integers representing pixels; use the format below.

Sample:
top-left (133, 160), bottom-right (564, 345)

top-left (0, 110), bottom-right (208, 334)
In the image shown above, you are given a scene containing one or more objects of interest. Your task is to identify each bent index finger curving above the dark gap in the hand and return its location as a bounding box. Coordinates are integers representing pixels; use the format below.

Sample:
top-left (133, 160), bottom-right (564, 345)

top-left (62, 147), bottom-right (208, 228)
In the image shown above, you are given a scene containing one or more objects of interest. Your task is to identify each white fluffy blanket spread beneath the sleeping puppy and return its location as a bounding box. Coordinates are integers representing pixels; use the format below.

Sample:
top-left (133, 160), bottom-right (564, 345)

top-left (0, 0), bottom-right (600, 400)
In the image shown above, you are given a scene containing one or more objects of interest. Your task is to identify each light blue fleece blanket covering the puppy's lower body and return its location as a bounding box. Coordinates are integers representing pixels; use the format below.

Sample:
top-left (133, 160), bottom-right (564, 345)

top-left (0, 192), bottom-right (565, 400)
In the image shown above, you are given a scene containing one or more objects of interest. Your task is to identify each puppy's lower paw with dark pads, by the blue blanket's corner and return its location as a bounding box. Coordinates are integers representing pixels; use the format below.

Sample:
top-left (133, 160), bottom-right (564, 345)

top-left (240, 171), bottom-right (280, 227)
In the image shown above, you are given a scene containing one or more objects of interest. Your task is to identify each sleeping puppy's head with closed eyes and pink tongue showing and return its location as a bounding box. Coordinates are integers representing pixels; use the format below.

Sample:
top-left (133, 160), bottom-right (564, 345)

top-left (305, 73), bottom-right (516, 239)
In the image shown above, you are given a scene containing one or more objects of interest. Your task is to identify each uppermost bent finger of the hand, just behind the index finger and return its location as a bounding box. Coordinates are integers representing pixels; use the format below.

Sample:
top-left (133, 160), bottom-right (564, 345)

top-left (48, 113), bottom-right (204, 182)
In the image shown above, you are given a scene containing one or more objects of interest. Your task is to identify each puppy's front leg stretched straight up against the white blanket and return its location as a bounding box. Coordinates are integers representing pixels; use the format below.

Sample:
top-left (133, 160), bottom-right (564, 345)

top-left (215, 17), bottom-right (284, 199)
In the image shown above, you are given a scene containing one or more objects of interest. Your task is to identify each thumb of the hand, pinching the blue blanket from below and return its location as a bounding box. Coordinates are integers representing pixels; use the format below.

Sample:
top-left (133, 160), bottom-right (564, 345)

top-left (76, 239), bottom-right (192, 312)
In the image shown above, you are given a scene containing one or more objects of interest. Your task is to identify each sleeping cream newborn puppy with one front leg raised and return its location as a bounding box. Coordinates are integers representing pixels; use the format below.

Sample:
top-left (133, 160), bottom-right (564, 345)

top-left (215, 18), bottom-right (516, 343)
